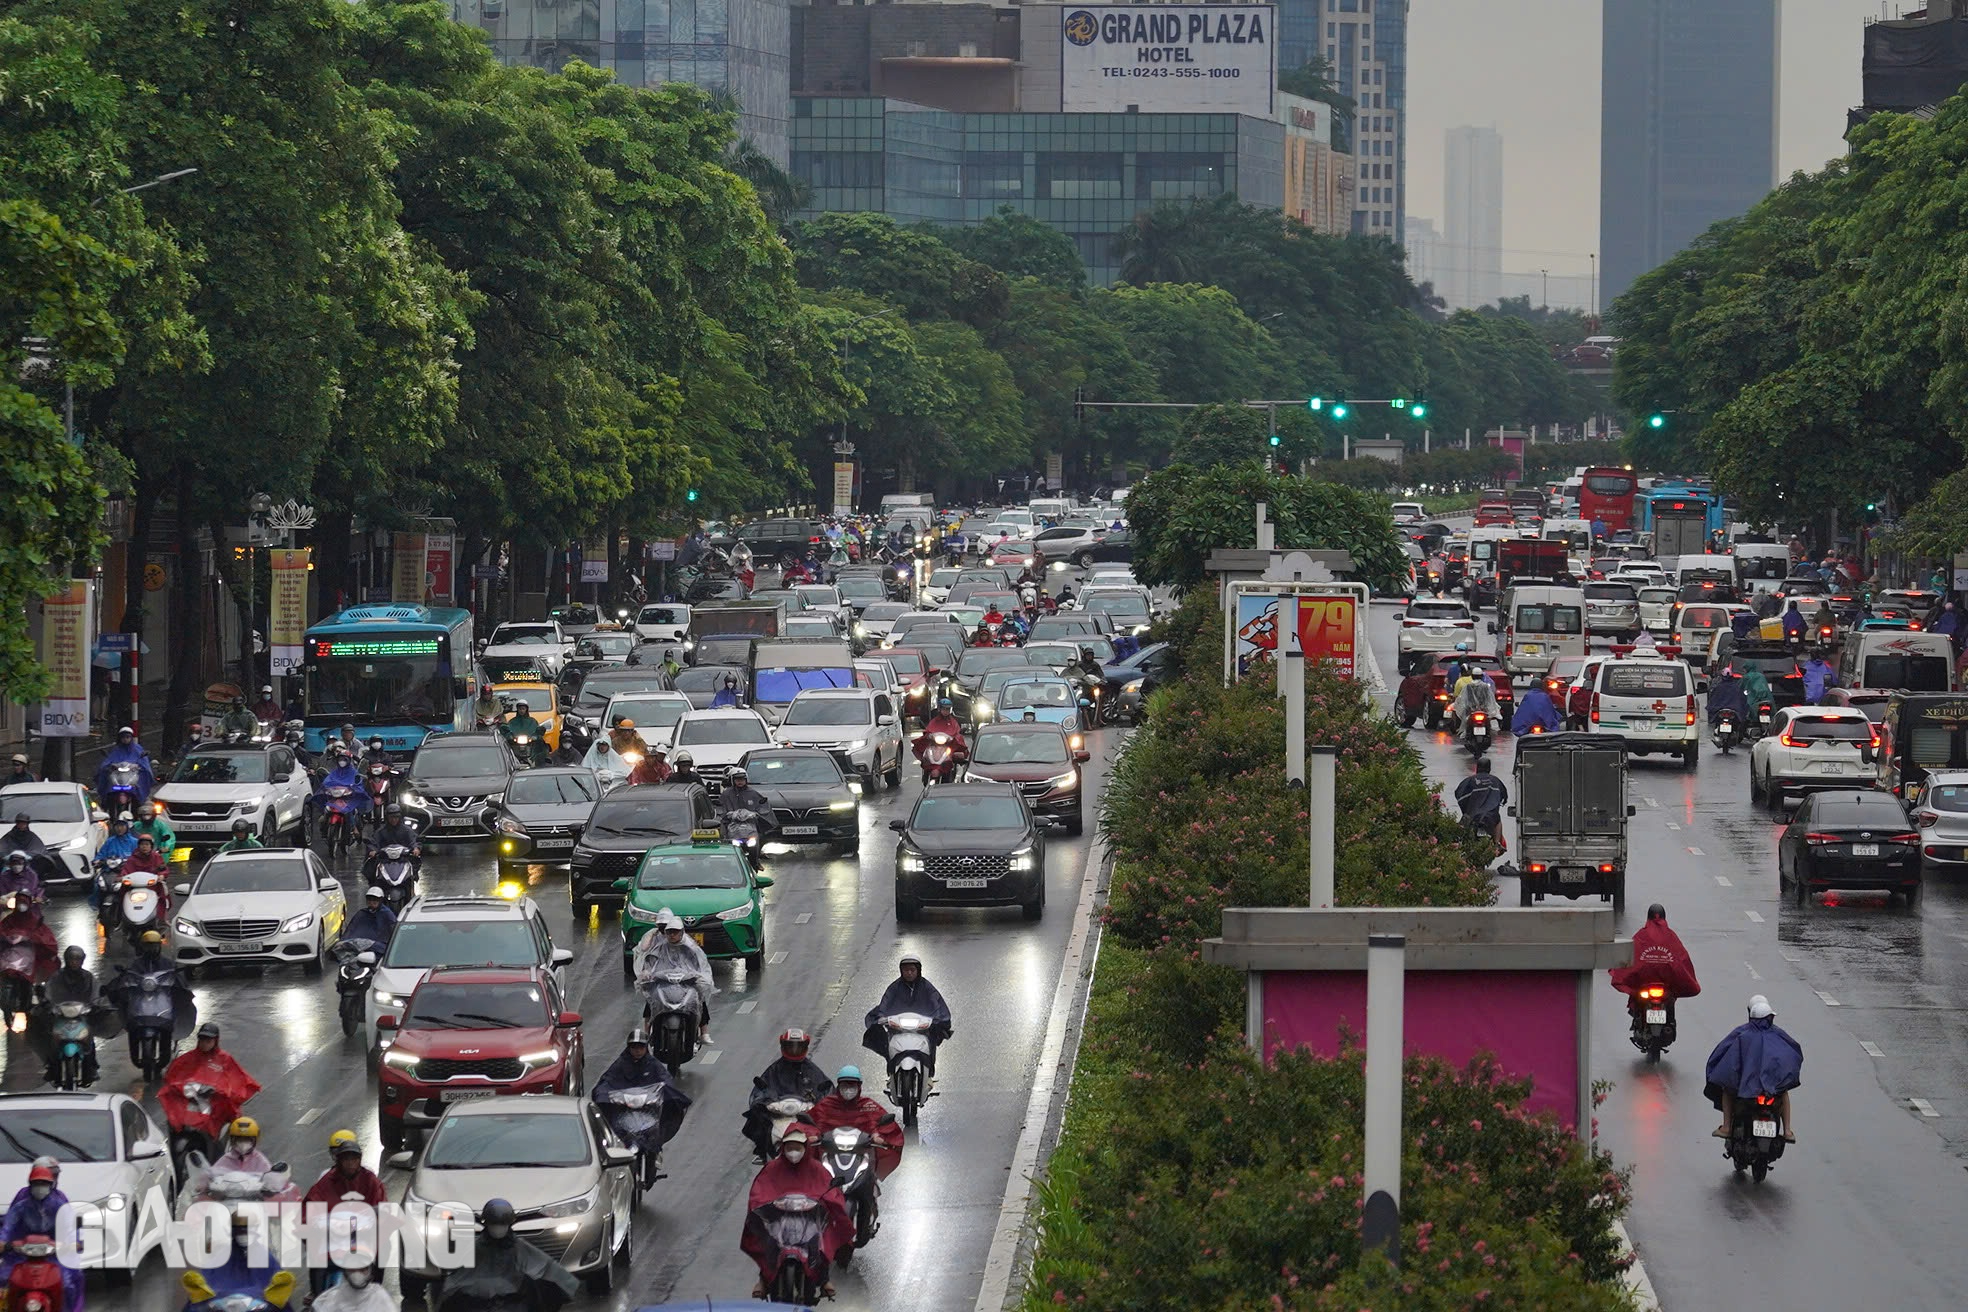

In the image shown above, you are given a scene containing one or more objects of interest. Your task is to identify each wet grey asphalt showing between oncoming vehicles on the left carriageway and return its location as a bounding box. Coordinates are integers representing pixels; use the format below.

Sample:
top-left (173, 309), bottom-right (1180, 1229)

top-left (0, 590), bottom-right (1124, 1312)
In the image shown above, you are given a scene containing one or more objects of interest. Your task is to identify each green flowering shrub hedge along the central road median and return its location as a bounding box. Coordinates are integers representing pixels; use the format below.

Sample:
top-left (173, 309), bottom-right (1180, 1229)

top-left (1025, 596), bottom-right (1628, 1312)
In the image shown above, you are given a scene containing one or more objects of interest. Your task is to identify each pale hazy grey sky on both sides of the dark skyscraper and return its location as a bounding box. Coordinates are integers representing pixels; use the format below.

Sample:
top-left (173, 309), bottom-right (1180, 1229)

top-left (1407, 0), bottom-right (1881, 303)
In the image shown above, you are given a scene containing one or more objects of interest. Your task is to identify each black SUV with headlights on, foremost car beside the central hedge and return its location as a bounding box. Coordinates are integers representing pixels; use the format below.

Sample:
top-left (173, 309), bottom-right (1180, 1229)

top-left (888, 783), bottom-right (1059, 921)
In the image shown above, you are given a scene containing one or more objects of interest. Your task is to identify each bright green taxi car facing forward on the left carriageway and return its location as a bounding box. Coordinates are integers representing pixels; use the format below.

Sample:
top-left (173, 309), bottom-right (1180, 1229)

top-left (614, 830), bottom-right (771, 980)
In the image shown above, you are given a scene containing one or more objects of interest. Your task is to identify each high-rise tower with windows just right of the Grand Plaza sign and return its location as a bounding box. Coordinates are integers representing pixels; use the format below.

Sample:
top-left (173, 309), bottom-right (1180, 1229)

top-left (1277, 0), bottom-right (1407, 242)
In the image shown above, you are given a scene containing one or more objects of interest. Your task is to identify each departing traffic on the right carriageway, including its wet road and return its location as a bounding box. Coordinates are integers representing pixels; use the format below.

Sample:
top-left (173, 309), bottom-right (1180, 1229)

top-left (1368, 468), bottom-right (1968, 1308)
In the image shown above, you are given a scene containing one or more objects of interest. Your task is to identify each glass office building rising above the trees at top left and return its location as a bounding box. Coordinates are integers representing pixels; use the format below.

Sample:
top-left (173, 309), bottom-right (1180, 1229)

top-left (451, 0), bottom-right (793, 163)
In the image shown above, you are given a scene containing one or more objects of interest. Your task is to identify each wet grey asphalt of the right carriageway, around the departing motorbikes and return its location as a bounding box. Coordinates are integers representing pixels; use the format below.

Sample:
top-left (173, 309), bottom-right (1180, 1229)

top-left (1372, 606), bottom-right (1968, 1312)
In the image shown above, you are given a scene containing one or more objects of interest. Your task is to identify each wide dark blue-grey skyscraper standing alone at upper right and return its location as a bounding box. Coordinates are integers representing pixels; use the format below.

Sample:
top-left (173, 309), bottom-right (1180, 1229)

top-left (1600, 0), bottom-right (1779, 303)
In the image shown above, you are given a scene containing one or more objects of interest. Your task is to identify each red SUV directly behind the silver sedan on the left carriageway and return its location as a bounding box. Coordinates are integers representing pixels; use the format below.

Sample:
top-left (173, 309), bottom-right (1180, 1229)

top-left (376, 966), bottom-right (583, 1153)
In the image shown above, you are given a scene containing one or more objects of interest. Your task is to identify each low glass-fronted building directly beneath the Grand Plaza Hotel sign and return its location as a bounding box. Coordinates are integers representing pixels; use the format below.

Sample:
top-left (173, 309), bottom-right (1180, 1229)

top-left (791, 96), bottom-right (1285, 287)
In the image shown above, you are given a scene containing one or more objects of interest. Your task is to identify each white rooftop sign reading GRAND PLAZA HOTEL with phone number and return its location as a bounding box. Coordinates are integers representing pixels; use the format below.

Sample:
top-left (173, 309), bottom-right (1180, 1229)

top-left (1059, 4), bottom-right (1277, 118)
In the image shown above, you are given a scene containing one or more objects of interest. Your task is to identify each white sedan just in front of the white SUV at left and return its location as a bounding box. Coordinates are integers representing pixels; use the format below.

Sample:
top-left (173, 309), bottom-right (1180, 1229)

top-left (171, 848), bottom-right (348, 976)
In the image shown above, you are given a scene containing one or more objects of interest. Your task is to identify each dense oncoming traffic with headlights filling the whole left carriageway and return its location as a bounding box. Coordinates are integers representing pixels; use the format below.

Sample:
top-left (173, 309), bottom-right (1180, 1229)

top-left (0, 498), bottom-right (1163, 1312)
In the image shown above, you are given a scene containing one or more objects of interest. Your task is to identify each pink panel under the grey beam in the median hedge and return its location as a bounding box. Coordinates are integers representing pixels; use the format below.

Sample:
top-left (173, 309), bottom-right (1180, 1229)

top-left (1263, 970), bottom-right (1584, 1127)
